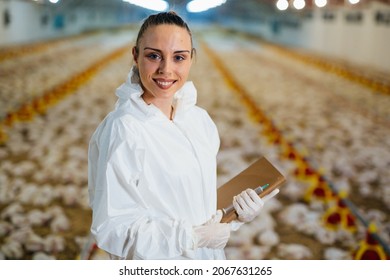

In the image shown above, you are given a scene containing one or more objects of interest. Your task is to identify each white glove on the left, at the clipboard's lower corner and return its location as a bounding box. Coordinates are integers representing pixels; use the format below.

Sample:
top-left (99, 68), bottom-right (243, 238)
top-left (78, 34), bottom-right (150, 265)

top-left (193, 210), bottom-right (230, 249)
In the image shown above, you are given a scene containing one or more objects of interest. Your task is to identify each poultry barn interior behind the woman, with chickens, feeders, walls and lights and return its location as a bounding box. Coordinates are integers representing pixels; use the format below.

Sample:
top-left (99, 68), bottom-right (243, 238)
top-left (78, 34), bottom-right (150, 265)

top-left (0, 0), bottom-right (390, 260)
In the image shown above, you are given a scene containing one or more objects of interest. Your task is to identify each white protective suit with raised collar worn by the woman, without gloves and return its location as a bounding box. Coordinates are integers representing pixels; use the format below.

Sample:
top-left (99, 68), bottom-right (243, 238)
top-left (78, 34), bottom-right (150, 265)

top-left (88, 66), bottom-right (225, 259)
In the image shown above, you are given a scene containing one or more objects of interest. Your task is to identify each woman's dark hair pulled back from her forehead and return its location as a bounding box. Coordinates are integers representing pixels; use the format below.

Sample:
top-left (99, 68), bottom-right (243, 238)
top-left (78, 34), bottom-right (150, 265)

top-left (135, 11), bottom-right (195, 57)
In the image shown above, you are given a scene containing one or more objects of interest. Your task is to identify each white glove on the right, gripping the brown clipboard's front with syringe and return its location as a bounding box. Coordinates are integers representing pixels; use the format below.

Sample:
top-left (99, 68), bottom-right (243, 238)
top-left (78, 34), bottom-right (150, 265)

top-left (233, 189), bottom-right (279, 223)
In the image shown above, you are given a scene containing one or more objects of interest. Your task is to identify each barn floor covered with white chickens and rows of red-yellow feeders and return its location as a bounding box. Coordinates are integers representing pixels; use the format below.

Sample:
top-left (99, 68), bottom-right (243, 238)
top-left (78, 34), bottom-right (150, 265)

top-left (0, 29), bottom-right (390, 259)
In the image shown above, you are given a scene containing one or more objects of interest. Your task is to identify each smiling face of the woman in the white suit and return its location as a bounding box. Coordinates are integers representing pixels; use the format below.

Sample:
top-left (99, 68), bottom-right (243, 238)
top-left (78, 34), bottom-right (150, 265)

top-left (133, 24), bottom-right (192, 103)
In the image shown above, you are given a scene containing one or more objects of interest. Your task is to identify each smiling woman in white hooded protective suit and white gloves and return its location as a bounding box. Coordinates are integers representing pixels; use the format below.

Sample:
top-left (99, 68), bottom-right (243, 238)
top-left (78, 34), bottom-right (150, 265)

top-left (89, 12), bottom-right (278, 259)
